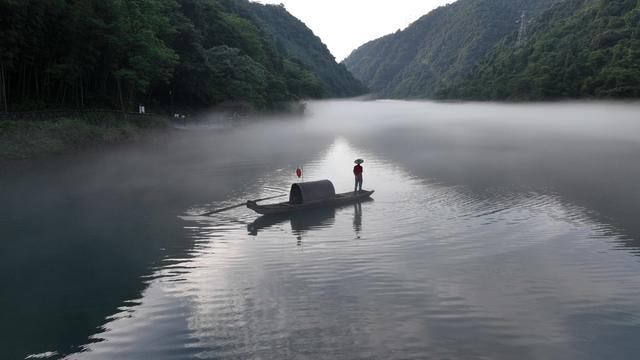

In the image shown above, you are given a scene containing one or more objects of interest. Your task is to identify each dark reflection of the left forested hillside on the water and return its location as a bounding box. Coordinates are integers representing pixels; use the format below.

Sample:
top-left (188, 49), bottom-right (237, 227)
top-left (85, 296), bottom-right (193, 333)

top-left (0, 122), bottom-right (333, 359)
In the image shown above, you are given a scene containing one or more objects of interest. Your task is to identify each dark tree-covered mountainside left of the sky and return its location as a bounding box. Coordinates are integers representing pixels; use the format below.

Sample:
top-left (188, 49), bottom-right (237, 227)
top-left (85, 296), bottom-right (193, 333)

top-left (0, 0), bottom-right (364, 111)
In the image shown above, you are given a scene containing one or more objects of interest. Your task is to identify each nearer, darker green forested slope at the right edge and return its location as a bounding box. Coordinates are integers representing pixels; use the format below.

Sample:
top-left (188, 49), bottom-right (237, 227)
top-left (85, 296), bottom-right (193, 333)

top-left (439, 0), bottom-right (640, 100)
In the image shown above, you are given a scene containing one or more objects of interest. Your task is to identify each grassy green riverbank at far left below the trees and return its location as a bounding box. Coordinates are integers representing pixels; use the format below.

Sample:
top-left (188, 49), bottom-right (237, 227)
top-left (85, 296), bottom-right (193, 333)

top-left (0, 113), bottom-right (170, 159)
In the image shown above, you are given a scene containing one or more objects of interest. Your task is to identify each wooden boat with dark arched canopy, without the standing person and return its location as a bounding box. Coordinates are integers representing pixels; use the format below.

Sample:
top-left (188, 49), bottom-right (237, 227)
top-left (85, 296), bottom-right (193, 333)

top-left (247, 180), bottom-right (374, 215)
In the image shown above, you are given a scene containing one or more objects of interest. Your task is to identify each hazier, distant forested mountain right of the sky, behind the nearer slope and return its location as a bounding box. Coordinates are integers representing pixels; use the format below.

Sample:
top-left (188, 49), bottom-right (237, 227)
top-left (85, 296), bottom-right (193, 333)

top-left (344, 0), bottom-right (558, 98)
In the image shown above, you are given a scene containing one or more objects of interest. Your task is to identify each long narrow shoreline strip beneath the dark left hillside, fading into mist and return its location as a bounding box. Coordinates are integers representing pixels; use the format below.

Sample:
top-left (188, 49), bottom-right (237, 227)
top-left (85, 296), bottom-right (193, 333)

top-left (0, 102), bottom-right (306, 162)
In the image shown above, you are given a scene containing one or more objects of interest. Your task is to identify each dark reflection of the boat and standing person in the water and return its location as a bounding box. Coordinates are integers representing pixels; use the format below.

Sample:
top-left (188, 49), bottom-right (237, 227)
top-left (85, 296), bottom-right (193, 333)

top-left (247, 199), bottom-right (373, 240)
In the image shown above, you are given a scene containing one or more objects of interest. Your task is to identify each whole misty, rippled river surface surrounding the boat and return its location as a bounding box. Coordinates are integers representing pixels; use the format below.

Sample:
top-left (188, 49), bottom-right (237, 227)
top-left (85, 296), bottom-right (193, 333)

top-left (0, 101), bottom-right (640, 359)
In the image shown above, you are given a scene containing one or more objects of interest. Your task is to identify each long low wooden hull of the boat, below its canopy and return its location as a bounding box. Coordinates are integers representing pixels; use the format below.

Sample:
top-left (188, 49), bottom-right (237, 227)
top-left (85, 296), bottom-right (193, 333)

top-left (247, 190), bottom-right (374, 215)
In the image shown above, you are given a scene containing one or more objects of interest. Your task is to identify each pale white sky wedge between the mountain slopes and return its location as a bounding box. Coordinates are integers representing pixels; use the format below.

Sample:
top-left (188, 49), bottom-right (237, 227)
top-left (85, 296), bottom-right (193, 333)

top-left (257, 0), bottom-right (454, 61)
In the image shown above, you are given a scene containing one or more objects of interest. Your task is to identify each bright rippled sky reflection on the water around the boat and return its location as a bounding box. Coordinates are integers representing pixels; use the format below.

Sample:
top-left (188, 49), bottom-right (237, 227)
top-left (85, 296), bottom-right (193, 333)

top-left (72, 136), bottom-right (640, 359)
